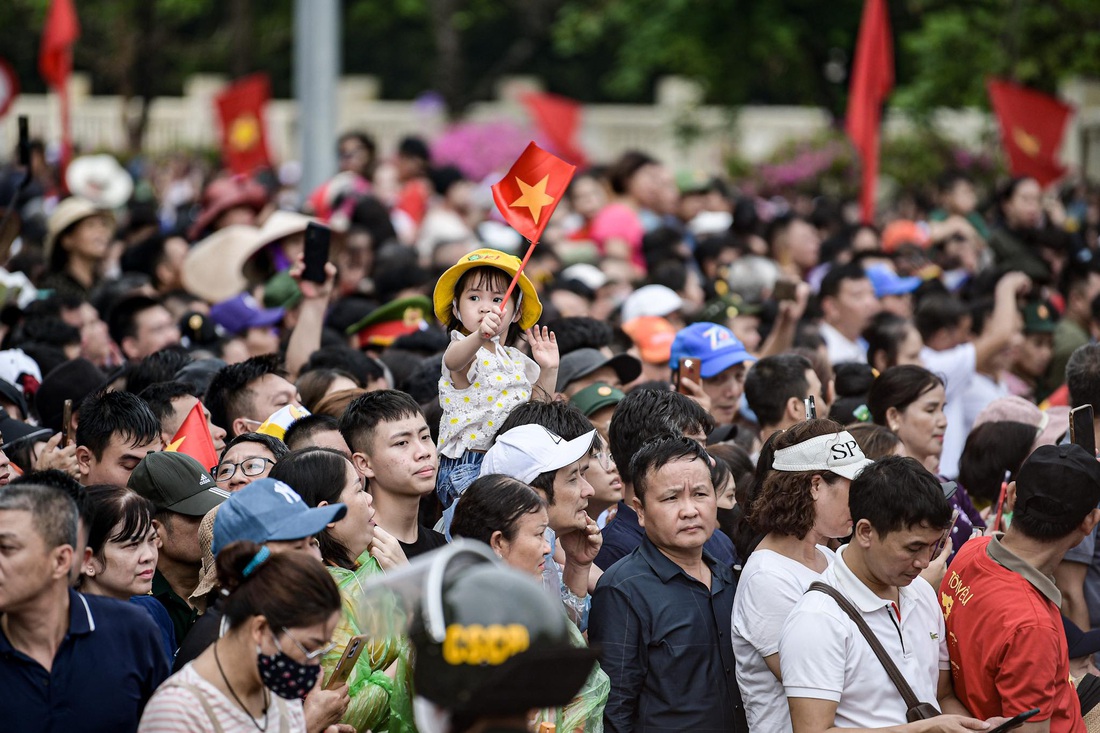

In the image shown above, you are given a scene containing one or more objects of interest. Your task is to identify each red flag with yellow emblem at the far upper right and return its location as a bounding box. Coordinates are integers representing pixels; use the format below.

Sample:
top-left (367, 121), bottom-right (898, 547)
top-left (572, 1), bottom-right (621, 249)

top-left (987, 79), bottom-right (1074, 187)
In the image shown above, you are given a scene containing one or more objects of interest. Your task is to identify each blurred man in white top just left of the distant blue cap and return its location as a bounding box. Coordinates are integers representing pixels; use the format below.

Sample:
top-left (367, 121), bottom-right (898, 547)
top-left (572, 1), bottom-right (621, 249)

top-left (820, 262), bottom-right (880, 364)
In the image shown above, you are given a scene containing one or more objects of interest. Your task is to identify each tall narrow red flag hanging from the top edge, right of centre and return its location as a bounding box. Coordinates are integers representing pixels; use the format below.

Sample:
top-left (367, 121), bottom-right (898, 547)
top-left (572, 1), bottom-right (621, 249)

top-left (845, 0), bottom-right (893, 223)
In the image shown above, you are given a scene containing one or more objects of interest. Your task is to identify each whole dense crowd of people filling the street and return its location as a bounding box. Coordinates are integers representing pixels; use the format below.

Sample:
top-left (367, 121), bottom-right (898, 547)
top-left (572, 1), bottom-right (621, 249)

top-left (0, 127), bottom-right (1100, 733)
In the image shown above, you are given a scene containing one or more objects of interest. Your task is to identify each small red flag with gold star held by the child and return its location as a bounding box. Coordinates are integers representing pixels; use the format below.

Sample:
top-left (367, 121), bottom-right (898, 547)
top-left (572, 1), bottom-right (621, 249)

top-left (493, 143), bottom-right (576, 244)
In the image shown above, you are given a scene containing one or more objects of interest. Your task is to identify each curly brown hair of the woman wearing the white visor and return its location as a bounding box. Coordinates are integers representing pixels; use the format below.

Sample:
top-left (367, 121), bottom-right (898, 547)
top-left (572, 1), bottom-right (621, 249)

top-left (745, 419), bottom-right (844, 539)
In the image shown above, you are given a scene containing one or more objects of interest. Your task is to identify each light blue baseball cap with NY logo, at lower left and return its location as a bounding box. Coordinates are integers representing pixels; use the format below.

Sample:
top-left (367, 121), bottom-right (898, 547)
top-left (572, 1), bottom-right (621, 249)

top-left (210, 479), bottom-right (348, 555)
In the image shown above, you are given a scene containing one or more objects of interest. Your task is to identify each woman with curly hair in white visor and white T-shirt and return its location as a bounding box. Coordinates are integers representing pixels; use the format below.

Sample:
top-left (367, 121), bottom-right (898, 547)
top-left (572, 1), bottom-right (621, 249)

top-left (733, 419), bottom-right (871, 733)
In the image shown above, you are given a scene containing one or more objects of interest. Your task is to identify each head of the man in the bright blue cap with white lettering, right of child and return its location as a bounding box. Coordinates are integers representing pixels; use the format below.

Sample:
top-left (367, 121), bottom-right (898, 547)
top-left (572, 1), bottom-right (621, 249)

top-left (669, 322), bottom-right (754, 425)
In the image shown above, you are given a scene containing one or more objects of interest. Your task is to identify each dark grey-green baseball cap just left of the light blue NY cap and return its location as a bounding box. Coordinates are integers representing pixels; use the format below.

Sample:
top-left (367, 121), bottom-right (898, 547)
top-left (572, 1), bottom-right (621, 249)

top-left (127, 451), bottom-right (229, 516)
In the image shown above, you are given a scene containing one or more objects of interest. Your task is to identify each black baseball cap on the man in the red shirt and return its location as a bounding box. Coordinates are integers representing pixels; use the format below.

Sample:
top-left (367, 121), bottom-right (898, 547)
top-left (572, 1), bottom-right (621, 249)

top-left (1015, 442), bottom-right (1100, 524)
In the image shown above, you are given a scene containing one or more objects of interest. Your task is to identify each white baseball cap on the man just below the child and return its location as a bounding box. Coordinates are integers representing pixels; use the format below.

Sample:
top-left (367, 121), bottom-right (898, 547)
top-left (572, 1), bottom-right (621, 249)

top-left (480, 425), bottom-right (596, 483)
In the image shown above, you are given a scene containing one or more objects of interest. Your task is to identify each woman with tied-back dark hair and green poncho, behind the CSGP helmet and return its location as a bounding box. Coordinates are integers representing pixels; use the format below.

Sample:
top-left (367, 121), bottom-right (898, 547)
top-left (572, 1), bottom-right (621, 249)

top-left (451, 473), bottom-right (611, 733)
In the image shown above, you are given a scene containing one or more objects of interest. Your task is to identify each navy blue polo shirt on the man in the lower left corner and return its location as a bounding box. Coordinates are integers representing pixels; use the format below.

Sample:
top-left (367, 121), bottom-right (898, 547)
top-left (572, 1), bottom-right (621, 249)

top-left (0, 590), bottom-right (168, 733)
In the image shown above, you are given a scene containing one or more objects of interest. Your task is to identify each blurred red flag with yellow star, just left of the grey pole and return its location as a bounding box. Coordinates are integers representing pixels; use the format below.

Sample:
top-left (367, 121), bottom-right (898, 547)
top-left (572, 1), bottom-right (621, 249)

top-left (215, 74), bottom-right (271, 175)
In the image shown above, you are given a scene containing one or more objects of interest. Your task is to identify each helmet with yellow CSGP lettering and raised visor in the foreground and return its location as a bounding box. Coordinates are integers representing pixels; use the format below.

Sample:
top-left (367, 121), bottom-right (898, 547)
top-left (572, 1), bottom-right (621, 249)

top-left (356, 539), bottom-right (596, 715)
